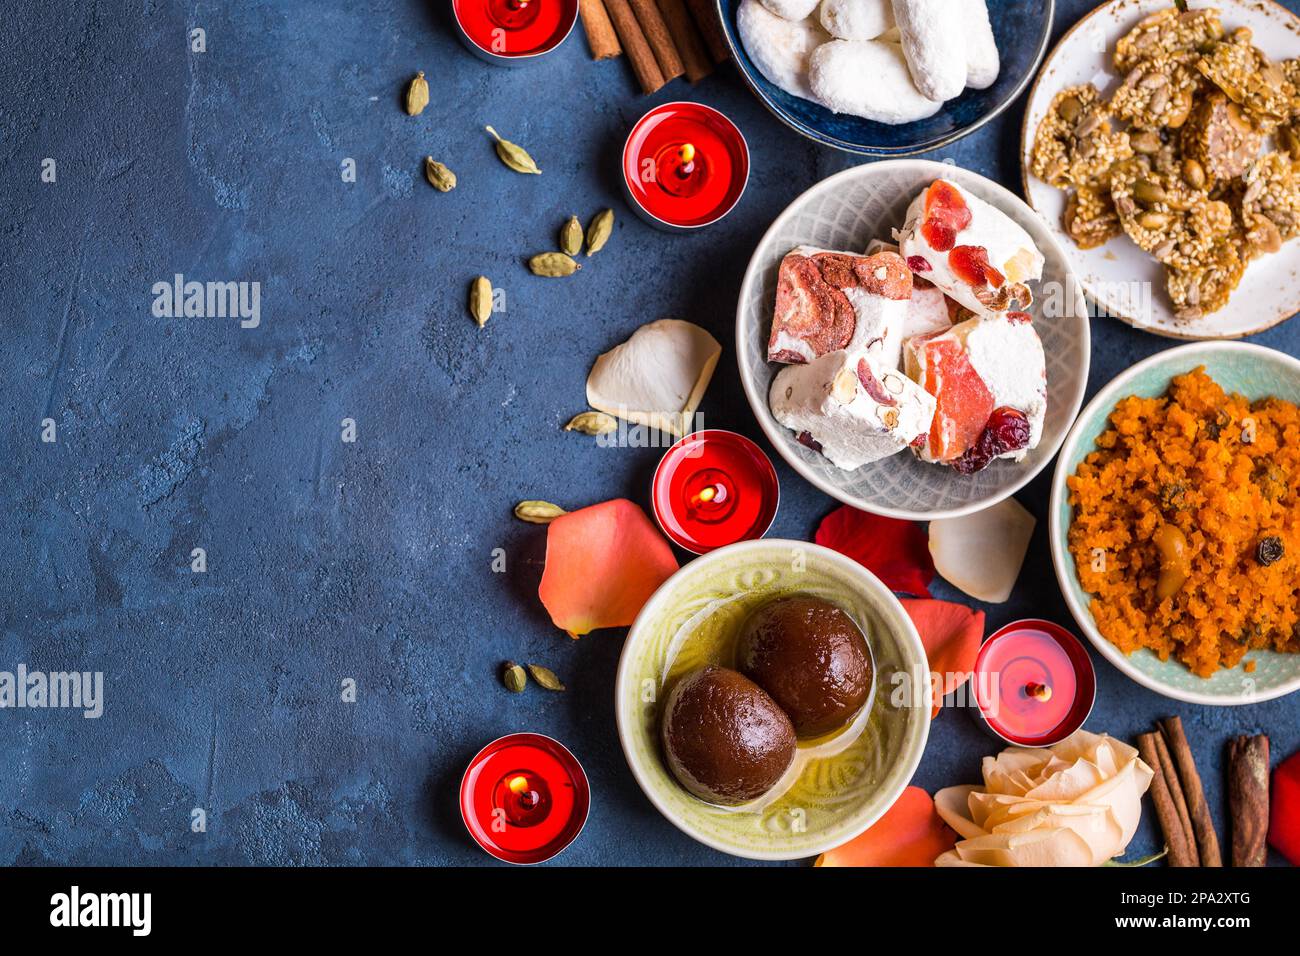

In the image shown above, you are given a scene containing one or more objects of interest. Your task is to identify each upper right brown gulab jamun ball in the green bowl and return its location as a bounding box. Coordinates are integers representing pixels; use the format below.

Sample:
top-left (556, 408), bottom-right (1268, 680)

top-left (736, 596), bottom-right (872, 737)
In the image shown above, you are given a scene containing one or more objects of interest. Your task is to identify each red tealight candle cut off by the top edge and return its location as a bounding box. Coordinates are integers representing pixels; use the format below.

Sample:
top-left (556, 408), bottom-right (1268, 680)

top-left (451, 0), bottom-right (577, 65)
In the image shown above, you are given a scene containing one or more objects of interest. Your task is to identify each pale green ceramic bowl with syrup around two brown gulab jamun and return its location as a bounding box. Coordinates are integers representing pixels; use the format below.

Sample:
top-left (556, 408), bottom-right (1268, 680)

top-left (615, 540), bottom-right (930, 860)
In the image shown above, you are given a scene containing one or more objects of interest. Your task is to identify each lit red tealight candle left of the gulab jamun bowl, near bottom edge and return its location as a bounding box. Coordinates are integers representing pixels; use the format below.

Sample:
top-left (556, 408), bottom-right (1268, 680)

top-left (460, 734), bottom-right (592, 864)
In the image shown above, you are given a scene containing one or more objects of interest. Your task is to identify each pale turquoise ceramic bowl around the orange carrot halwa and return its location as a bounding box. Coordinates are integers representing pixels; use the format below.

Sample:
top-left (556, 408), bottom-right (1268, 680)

top-left (1049, 342), bottom-right (1300, 705)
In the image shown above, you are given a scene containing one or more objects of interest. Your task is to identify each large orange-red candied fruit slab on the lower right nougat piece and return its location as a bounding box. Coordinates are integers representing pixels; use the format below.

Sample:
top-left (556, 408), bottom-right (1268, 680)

top-left (911, 333), bottom-right (993, 462)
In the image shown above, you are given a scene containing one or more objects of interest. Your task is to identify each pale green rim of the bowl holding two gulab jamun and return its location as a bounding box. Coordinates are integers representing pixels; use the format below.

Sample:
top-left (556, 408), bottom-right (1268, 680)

top-left (614, 537), bottom-right (932, 861)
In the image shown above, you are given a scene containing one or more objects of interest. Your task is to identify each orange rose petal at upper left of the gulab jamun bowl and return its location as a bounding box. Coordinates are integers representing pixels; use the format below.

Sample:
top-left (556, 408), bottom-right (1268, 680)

top-left (537, 498), bottom-right (677, 637)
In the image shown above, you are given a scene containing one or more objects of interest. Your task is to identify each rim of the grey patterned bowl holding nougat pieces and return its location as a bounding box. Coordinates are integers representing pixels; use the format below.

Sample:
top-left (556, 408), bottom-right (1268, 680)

top-left (735, 159), bottom-right (1092, 522)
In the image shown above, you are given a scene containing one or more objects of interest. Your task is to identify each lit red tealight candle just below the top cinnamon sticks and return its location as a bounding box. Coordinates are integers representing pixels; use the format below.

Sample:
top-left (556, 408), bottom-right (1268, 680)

top-left (623, 103), bottom-right (749, 229)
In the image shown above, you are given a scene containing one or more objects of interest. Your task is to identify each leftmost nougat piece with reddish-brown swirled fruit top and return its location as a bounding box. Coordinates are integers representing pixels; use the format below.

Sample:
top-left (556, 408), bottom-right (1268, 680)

top-left (767, 246), bottom-right (911, 364)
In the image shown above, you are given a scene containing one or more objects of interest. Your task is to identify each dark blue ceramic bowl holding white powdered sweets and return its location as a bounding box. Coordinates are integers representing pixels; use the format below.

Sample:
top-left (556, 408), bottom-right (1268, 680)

top-left (718, 0), bottom-right (1056, 157)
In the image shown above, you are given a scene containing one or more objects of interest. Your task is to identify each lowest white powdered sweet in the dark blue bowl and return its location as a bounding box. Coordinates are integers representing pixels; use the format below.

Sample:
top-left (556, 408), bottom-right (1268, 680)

top-left (809, 40), bottom-right (944, 124)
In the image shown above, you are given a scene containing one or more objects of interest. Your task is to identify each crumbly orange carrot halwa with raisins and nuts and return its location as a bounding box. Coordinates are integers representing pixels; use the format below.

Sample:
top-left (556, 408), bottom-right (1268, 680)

top-left (1066, 367), bottom-right (1300, 678)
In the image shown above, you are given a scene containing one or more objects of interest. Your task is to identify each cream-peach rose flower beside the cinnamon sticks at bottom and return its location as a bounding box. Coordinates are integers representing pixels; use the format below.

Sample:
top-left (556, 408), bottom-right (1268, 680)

top-left (935, 730), bottom-right (1152, 866)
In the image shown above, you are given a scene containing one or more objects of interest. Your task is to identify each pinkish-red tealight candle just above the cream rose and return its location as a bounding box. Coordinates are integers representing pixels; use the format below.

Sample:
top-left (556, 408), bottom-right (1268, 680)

top-left (974, 619), bottom-right (1097, 747)
